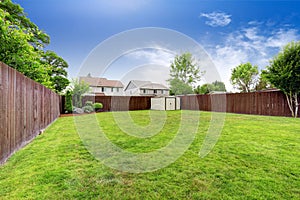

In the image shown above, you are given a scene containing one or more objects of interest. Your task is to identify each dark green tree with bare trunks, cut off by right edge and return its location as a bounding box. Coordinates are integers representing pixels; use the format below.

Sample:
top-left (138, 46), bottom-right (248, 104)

top-left (266, 41), bottom-right (300, 117)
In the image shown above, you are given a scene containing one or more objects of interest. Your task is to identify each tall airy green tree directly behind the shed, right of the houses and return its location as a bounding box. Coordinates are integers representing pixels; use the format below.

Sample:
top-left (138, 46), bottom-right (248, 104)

top-left (168, 52), bottom-right (203, 94)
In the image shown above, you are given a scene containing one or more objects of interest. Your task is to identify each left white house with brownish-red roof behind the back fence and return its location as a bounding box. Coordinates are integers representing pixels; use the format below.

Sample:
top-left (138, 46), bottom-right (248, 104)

top-left (79, 74), bottom-right (124, 96)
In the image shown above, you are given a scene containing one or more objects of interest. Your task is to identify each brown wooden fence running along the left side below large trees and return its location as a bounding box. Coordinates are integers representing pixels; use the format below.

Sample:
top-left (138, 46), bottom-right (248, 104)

top-left (0, 62), bottom-right (61, 164)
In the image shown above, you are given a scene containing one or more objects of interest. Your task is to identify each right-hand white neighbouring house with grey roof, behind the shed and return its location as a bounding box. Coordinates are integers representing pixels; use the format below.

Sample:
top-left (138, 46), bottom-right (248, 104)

top-left (124, 80), bottom-right (169, 96)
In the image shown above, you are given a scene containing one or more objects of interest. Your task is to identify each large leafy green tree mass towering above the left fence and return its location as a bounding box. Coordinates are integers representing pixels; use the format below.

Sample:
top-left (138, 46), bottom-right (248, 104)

top-left (0, 0), bottom-right (68, 91)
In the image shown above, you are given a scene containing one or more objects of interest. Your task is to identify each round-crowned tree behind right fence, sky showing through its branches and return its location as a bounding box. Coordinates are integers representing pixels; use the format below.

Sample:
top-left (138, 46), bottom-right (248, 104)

top-left (230, 62), bottom-right (258, 92)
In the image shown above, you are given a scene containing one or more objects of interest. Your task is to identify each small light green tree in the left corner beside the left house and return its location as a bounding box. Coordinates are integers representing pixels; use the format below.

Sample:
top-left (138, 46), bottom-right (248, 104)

top-left (69, 79), bottom-right (90, 108)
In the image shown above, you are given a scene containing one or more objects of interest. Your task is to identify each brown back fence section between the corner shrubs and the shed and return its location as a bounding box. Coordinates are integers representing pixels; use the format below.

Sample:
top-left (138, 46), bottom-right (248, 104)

top-left (82, 96), bottom-right (152, 111)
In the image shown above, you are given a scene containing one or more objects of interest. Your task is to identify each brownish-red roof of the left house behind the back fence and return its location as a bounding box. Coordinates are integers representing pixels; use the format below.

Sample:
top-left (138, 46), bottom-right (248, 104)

top-left (79, 77), bottom-right (124, 88)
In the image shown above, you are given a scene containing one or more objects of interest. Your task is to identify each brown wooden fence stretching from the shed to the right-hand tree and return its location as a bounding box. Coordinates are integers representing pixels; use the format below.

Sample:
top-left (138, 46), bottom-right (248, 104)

top-left (181, 91), bottom-right (300, 116)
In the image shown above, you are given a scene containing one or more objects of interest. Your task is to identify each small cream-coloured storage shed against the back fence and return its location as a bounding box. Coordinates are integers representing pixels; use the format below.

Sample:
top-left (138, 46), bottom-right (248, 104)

top-left (151, 96), bottom-right (180, 110)
